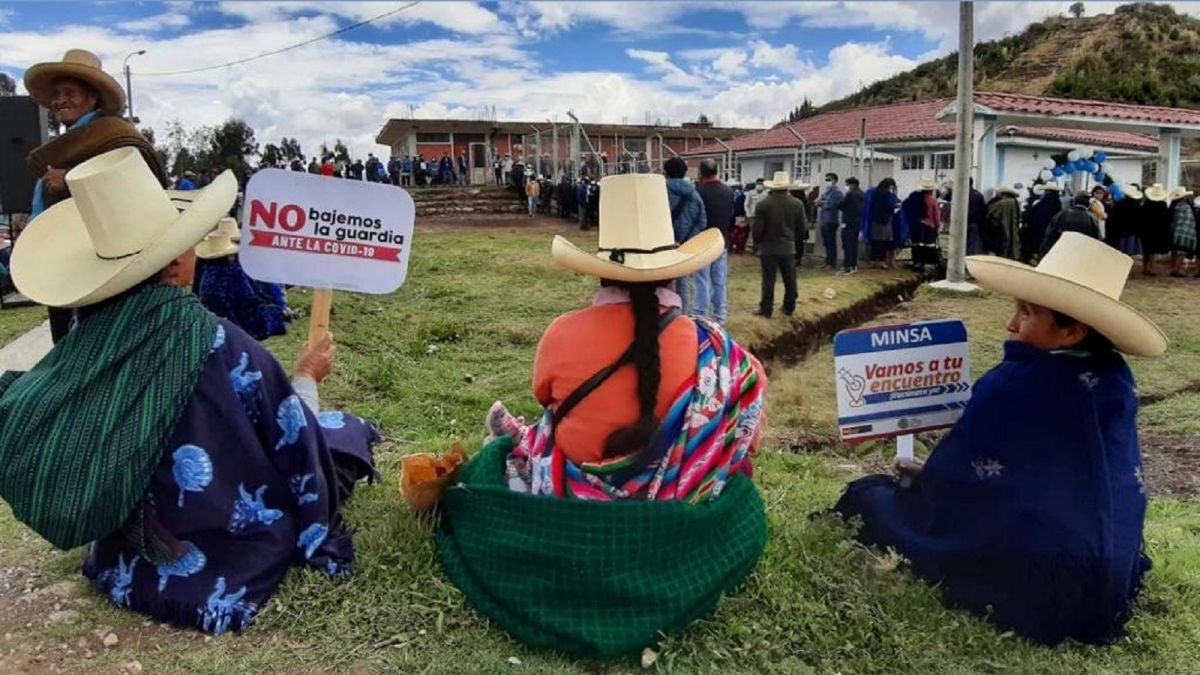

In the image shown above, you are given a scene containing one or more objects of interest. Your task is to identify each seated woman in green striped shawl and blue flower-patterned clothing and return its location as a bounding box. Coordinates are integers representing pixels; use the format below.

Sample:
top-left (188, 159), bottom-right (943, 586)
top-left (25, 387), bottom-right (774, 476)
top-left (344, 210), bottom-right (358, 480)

top-left (0, 148), bottom-right (378, 633)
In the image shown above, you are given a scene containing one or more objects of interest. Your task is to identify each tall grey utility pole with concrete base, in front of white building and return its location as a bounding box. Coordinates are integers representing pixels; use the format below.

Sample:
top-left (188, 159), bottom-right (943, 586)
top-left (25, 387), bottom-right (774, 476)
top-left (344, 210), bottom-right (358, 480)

top-left (934, 2), bottom-right (977, 291)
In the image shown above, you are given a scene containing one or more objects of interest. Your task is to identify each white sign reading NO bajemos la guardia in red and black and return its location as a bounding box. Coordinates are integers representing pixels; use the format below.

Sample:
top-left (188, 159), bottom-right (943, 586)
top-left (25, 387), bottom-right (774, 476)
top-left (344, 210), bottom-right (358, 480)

top-left (238, 169), bottom-right (416, 293)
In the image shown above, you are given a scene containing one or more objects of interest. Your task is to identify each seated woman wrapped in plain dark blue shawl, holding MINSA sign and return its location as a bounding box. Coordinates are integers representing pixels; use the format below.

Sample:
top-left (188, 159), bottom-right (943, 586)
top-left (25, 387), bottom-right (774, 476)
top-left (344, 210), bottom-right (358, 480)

top-left (835, 232), bottom-right (1166, 645)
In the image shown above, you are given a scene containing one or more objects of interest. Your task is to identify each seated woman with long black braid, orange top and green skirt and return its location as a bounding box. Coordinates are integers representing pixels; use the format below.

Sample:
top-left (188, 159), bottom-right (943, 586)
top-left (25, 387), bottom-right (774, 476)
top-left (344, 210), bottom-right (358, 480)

top-left (438, 174), bottom-right (767, 657)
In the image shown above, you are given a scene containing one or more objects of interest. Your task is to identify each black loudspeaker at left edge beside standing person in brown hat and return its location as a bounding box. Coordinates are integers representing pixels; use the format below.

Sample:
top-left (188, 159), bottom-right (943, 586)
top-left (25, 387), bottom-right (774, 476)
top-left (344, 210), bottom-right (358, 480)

top-left (0, 96), bottom-right (47, 214)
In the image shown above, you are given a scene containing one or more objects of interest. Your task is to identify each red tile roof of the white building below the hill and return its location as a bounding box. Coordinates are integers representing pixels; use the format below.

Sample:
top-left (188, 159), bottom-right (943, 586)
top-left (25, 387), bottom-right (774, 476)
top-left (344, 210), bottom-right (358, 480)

top-left (683, 94), bottom-right (1166, 156)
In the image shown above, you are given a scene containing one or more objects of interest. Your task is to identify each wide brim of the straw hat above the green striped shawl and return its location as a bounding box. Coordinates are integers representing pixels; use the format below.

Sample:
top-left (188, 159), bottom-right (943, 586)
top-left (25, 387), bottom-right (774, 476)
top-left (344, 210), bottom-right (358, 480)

top-left (12, 171), bottom-right (238, 307)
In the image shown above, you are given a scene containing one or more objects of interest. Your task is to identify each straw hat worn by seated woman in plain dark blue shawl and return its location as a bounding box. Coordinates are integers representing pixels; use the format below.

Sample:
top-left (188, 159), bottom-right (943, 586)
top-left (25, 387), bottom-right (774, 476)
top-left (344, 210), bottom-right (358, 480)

top-left (967, 232), bottom-right (1166, 357)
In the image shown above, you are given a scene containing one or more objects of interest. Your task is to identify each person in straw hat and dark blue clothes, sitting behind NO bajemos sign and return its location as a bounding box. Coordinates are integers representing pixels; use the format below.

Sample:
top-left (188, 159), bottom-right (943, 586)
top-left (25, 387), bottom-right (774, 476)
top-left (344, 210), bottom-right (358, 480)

top-left (196, 217), bottom-right (288, 340)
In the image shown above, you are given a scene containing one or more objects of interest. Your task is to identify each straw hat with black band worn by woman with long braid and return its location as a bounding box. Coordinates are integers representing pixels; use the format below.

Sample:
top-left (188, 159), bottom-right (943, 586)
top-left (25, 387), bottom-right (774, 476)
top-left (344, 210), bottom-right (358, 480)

top-left (550, 174), bottom-right (725, 283)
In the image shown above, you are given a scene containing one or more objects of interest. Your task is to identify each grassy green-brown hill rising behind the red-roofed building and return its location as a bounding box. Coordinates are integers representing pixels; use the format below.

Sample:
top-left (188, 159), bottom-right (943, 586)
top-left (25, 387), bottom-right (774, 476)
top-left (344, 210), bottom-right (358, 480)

top-left (805, 4), bottom-right (1200, 111)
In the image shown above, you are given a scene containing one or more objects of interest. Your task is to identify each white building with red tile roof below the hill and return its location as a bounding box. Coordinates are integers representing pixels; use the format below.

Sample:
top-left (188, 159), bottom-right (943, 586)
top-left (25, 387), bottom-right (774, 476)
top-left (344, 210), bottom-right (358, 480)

top-left (683, 92), bottom-right (1200, 195)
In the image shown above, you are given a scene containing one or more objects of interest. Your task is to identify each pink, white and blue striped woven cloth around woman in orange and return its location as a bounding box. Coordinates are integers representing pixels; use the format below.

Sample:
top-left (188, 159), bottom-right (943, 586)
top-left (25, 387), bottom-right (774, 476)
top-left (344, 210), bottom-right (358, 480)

top-left (506, 319), bottom-right (767, 503)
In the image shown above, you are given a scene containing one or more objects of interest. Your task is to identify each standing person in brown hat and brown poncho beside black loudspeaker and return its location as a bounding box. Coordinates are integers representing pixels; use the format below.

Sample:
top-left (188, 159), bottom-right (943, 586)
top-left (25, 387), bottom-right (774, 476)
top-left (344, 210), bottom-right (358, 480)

top-left (25, 49), bottom-right (167, 342)
